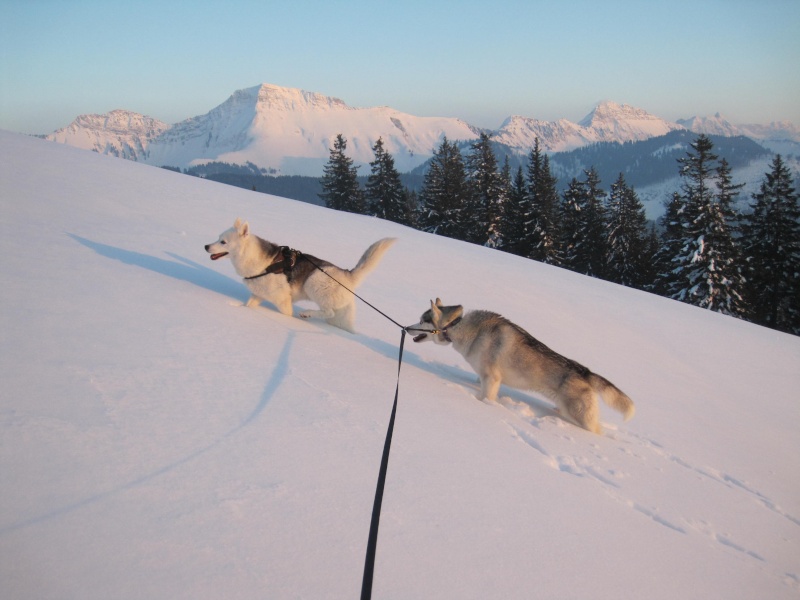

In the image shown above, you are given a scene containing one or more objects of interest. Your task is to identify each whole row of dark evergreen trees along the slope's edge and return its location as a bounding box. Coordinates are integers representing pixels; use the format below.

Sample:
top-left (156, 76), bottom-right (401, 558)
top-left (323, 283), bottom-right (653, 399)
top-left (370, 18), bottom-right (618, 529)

top-left (320, 134), bottom-right (800, 335)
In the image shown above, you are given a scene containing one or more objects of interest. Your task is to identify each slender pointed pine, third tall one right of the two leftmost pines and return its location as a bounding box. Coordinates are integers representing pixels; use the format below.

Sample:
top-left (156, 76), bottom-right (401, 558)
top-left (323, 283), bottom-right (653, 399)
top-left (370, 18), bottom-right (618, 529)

top-left (523, 138), bottom-right (561, 264)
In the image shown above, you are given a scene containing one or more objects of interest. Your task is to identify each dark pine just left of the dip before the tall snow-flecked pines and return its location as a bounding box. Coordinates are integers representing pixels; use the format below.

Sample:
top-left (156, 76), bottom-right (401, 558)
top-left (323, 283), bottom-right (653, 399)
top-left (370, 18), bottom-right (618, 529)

top-left (606, 173), bottom-right (652, 289)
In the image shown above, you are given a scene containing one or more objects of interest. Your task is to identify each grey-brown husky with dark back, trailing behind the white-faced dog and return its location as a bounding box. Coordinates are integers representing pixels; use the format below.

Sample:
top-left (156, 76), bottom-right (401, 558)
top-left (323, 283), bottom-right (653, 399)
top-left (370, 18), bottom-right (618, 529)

top-left (407, 298), bottom-right (634, 434)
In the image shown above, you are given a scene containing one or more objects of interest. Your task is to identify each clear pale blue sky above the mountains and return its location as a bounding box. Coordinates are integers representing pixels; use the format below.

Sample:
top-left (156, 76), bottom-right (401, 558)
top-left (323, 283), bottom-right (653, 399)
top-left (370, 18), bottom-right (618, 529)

top-left (0, 0), bottom-right (800, 133)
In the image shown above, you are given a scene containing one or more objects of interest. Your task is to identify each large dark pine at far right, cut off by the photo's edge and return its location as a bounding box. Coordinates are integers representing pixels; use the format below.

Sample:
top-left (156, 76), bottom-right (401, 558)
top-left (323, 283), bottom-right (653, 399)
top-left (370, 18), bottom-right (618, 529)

top-left (743, 155), bottom-right (800, 335)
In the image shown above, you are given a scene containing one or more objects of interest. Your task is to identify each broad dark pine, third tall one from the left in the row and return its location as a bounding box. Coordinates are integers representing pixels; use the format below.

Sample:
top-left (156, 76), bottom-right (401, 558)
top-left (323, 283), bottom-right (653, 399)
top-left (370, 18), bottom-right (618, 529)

top-left (419, 137), bottom-right (470, 240)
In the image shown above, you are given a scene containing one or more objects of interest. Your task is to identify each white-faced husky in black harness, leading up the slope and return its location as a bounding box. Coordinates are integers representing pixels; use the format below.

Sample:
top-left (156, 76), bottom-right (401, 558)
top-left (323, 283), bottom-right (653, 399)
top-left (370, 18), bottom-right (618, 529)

top-left (205, 219), bottom-right (395, 333)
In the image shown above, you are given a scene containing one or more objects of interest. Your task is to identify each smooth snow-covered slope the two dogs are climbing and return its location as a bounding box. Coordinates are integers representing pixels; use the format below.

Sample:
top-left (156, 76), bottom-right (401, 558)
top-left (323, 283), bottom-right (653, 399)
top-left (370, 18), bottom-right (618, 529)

top-left (0, 132), bottom-right (800, 600)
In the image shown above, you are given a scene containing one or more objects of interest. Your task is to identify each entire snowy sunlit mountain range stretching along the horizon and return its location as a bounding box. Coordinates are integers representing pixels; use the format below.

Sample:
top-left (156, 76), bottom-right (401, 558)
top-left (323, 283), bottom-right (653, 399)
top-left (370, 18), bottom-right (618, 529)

top-left (43, 83), bottom-right (800, 176)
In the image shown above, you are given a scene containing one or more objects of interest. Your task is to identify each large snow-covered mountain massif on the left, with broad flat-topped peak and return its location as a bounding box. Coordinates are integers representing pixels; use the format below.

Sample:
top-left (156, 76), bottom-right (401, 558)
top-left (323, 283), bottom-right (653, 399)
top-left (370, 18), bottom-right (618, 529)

top-left (47, 84), bottom-right (478, 176)
